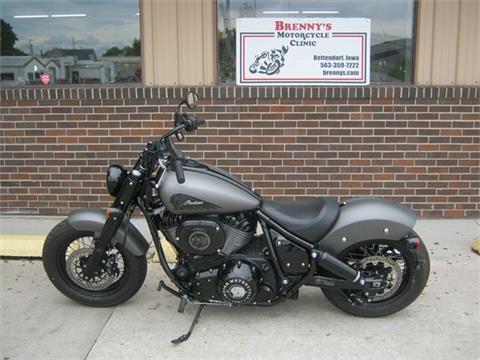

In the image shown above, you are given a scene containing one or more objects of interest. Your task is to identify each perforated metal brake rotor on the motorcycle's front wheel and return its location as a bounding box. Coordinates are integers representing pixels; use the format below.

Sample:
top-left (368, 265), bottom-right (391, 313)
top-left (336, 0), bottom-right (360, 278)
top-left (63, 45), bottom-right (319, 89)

top-left (66, 248), bottom-right (117, 291)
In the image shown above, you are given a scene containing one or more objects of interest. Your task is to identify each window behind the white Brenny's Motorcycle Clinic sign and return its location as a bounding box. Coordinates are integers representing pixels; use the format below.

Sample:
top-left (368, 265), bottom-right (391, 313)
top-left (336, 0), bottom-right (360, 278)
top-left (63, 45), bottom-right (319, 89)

top-left (217, 0), bottom-right (415, 84)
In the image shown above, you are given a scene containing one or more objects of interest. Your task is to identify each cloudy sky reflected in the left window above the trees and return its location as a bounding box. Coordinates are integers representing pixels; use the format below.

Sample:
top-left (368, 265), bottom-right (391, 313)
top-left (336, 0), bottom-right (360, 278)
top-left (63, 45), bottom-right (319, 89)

top-left (0, 0), bottom-right (140, 56)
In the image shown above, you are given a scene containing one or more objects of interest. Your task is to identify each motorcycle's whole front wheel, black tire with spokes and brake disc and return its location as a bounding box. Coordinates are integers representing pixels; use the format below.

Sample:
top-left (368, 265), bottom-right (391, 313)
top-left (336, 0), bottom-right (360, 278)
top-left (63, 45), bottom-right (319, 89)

top-left (42, 220), bottom-right (147, 307)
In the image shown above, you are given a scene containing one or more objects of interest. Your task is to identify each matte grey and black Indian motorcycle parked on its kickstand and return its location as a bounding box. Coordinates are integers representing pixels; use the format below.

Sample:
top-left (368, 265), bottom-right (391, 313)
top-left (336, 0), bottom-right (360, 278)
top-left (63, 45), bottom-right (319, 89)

top-left (43, 91), bottom-right (430, 343)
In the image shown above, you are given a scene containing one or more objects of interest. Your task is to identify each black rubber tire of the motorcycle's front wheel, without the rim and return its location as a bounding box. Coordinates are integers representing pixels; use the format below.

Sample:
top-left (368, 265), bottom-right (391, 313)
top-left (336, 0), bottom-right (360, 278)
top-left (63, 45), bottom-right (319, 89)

top-left (42, 219), bottom-right (147, 307)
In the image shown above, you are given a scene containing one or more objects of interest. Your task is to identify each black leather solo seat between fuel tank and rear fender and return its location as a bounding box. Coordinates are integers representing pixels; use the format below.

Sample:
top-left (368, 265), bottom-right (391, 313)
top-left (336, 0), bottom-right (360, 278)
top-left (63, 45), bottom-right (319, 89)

top-left (261, 197), bottom-right (340, 243)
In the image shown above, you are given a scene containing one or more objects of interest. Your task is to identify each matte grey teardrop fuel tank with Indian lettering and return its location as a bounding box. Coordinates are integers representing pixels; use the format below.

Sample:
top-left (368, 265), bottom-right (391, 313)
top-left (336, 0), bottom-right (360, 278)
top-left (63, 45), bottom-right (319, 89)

top-left (159, 168), bottom-right (260, 215)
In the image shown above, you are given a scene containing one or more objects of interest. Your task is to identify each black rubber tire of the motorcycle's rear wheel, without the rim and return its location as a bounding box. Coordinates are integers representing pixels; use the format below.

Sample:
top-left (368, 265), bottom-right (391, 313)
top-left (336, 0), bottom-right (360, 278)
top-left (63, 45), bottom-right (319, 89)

top-left (322, 240), bottom-right (430, 317)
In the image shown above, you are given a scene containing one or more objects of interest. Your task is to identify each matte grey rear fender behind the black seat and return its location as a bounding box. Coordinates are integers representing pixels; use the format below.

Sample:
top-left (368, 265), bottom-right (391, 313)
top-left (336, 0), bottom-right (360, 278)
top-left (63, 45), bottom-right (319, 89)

top-left (318, 198), bottom-right (417, 255)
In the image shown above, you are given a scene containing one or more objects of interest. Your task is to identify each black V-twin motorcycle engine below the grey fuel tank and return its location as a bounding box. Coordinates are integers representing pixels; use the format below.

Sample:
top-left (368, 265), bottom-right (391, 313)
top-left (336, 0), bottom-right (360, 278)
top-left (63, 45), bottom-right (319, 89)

top-left (158, 212), bottom-right (276, 305)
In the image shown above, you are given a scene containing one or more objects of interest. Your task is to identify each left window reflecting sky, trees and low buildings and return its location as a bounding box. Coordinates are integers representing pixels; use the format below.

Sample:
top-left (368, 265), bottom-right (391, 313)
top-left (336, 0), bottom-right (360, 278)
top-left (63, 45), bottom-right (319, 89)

top-left (0, 0), bottom-right (142, 85)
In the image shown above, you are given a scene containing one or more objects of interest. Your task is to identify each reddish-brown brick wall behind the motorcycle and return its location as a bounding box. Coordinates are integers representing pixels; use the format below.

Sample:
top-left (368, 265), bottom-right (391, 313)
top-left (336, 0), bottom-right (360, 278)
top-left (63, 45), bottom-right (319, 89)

top-left (0, 86), bottom-right (480, 217)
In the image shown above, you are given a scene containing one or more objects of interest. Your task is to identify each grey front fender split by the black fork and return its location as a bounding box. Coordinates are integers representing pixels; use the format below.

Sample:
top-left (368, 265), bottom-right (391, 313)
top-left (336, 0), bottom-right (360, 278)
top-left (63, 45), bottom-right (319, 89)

top-left (68, 209), bottom-right (150, 256)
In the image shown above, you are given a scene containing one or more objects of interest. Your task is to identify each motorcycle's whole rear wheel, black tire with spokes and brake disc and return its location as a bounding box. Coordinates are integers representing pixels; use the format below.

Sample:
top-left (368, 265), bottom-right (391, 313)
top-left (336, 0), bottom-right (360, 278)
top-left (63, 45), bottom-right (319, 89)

top-left (322, 239), bottom-right (430, 317)
